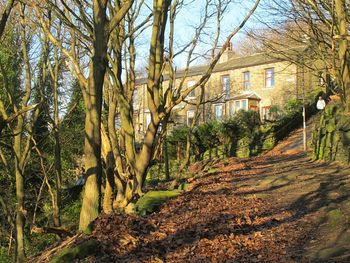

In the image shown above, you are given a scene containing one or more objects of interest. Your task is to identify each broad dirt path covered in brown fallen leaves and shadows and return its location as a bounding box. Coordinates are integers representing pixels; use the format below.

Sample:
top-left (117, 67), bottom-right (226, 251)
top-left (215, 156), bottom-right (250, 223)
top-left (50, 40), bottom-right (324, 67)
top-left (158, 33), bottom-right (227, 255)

top-left (91, 153), bottom-right (350, 262)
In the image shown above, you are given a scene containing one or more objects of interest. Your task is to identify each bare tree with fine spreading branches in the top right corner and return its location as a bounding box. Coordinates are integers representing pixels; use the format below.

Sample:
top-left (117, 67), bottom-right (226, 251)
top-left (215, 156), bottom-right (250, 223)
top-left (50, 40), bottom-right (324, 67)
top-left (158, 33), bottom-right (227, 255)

top-left (253, 0), bottom-right (350, 110)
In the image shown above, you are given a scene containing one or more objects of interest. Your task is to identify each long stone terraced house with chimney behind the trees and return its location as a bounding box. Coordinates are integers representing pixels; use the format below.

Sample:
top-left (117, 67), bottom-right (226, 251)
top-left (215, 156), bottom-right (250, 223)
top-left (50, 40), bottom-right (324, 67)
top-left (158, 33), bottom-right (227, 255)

top-left (134, 49), bottom-right (318, 138)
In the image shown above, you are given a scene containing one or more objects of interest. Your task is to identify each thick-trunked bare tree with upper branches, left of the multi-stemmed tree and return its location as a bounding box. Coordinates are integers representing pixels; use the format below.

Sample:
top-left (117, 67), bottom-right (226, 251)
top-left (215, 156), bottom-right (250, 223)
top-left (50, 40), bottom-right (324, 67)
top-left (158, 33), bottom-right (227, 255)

top-left (33, 0), bottom-right (133, 230)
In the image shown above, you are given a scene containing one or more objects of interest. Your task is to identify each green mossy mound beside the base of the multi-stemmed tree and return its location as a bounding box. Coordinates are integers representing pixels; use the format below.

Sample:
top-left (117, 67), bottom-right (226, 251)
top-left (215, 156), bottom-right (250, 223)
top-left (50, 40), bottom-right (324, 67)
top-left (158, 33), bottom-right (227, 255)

top-left (135, 190), bottom-right (182, 216)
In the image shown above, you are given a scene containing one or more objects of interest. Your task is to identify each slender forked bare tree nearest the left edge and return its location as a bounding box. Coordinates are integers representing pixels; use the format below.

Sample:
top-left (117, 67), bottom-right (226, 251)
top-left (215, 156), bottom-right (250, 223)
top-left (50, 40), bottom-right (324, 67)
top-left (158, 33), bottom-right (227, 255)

top-left (0, 4), bottom-right (39, 262)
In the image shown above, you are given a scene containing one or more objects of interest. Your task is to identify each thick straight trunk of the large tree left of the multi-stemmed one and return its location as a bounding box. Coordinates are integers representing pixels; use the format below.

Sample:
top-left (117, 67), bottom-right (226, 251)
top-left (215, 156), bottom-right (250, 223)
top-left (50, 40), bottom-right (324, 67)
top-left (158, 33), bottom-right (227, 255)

top-left (79, 0), bottom-right (108, 230)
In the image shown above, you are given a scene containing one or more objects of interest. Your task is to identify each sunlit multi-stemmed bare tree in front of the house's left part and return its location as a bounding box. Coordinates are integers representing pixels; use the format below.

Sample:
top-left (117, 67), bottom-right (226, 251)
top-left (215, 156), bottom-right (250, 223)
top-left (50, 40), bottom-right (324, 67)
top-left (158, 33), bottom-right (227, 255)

top-left (102, 0), bottom-right (259, 208)
